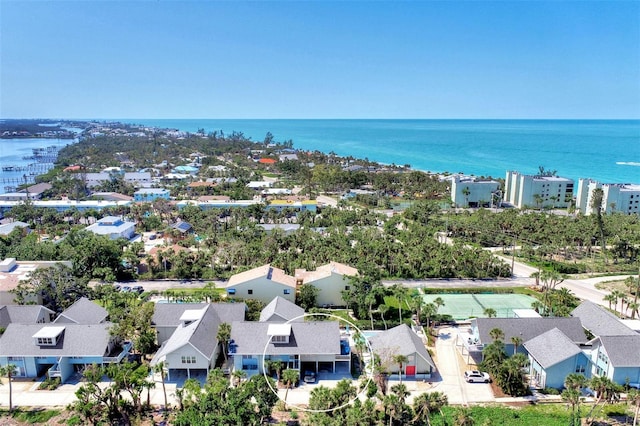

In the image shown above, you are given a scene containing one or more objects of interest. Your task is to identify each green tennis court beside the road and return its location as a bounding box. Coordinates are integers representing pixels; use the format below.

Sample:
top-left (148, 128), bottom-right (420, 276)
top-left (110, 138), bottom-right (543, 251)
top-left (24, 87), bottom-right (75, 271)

top-left (423, 293), bottom-right (536, 320)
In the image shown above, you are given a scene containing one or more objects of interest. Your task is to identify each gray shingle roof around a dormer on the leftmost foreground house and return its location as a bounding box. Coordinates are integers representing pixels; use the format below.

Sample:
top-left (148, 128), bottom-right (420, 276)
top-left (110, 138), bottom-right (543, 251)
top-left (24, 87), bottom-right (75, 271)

top-left (0, 323), bottom-right (111, 357)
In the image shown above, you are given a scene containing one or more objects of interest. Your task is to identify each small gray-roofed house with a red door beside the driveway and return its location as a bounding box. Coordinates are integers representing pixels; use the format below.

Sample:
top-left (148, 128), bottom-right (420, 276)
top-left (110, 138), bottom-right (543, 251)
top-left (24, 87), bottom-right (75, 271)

top-left (369, 324), bottom-right (436, 379)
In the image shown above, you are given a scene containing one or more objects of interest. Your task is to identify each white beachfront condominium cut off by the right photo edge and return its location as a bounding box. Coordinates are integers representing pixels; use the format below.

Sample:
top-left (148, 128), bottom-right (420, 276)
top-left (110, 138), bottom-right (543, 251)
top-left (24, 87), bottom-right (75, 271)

top-left (576, 179), bottom-right (640, 215)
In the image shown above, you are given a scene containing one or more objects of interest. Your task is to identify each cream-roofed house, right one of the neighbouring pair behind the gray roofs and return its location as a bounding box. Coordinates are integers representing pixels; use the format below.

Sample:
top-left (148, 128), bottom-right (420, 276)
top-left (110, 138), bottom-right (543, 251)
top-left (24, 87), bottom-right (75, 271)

top-left (295, 262), bottom-right (358, 306)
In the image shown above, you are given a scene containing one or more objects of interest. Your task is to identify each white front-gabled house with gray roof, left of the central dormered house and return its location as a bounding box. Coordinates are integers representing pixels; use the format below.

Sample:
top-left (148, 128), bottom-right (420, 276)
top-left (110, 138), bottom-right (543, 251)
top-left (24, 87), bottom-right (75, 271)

top-left (151, 303), bottom-right (246, 378)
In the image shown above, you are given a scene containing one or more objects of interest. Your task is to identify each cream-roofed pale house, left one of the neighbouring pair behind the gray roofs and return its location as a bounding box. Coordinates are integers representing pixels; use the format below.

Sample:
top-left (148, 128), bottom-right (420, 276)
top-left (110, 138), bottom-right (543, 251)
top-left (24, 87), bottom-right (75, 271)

top-left (226, 264), bottom-right (296, 303)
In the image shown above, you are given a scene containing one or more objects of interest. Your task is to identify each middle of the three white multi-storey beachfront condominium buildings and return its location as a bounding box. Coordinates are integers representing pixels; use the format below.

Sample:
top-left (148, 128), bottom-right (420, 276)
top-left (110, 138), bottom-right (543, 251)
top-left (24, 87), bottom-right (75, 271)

top-left (504, 171), bottom-right (573, 209)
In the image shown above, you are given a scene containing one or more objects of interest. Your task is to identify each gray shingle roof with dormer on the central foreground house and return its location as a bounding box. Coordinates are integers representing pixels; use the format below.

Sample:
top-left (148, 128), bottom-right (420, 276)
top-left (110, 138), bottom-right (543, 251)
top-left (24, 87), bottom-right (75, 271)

top-left (230, 321), bottom-right (340, 355)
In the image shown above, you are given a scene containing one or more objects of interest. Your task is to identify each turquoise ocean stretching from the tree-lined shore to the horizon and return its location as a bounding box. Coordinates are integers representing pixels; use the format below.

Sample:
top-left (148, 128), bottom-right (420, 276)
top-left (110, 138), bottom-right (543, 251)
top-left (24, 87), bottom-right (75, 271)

top-left (119, 119), bottom-right (640, 183)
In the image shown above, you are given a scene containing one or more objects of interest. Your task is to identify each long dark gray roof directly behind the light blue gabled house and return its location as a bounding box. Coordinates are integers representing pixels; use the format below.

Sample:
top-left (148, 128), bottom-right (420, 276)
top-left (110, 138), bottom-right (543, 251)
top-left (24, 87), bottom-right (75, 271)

top-left (476, 317), bottom-right (587, 344)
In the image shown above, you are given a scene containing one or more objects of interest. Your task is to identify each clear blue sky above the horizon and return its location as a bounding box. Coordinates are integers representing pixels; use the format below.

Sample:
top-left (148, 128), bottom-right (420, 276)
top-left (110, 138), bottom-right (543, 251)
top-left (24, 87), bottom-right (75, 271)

top-left (0, 0), bottom-right (640, 118)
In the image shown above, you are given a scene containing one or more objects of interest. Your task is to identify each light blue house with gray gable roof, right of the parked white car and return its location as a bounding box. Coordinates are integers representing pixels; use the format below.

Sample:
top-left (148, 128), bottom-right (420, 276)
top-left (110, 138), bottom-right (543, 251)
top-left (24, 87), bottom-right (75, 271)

top-left (523, 328), bottom-right (591, 389)
